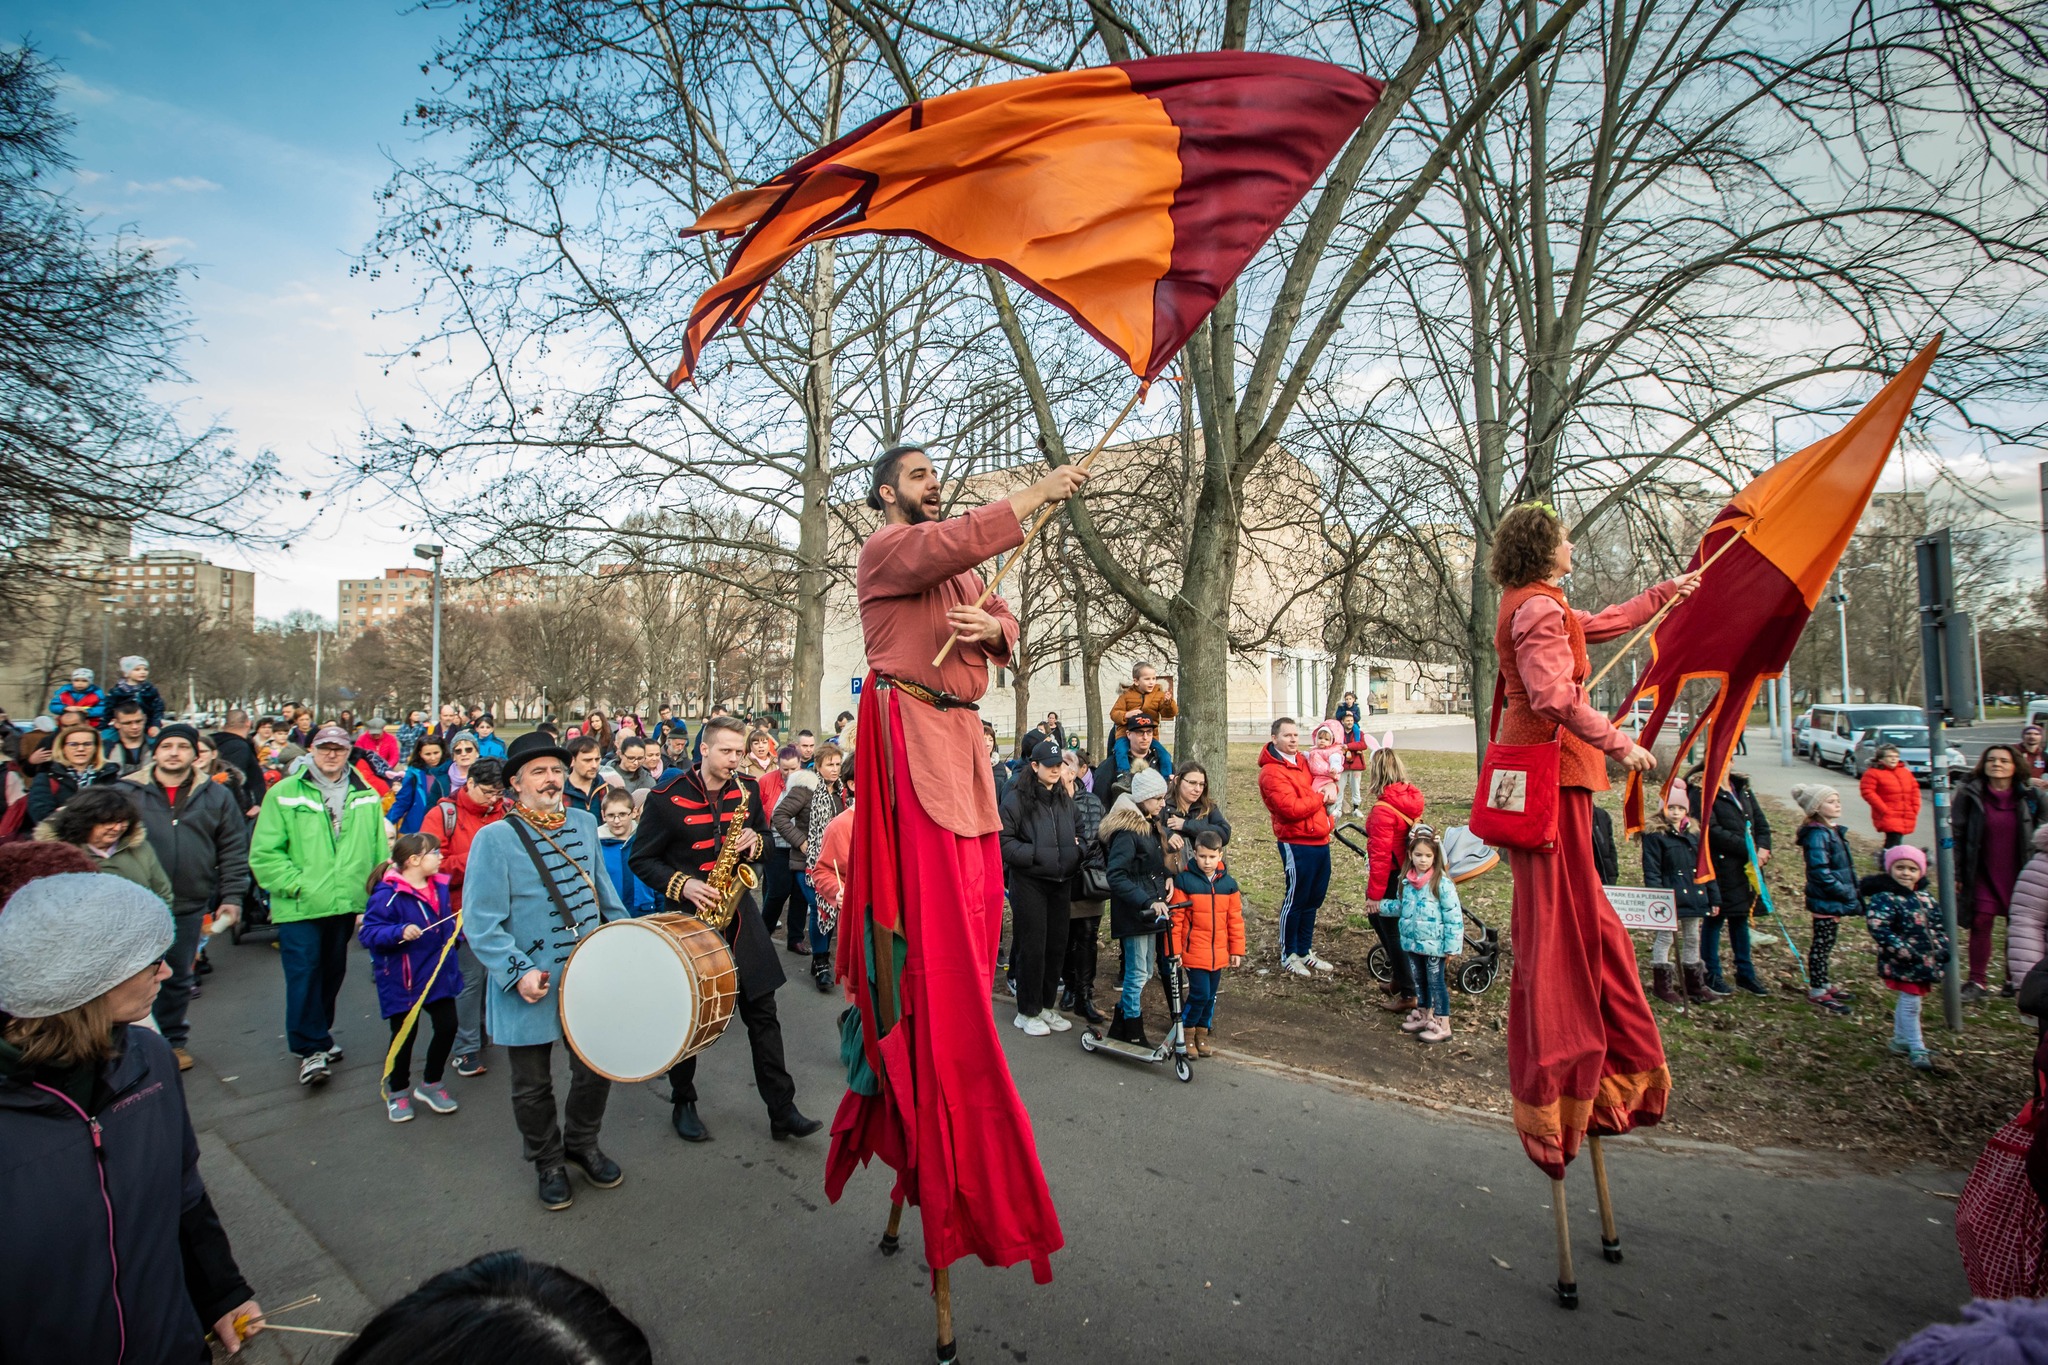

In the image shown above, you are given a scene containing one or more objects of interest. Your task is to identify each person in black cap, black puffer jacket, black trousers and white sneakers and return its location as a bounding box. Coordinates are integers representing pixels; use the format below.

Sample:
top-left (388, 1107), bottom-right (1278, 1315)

top-left (999, 739), bottom-right (1081, 1038)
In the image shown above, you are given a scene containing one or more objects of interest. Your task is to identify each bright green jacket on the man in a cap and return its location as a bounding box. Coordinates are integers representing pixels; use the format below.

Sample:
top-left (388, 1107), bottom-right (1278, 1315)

top-left (250, 772), bottom-right (391, 925)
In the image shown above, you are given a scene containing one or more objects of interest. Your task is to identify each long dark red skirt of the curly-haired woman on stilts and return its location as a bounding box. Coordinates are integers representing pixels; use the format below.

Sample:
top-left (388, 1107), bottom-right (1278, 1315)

top-left (1507, 786), bottom-right (1671, 1179)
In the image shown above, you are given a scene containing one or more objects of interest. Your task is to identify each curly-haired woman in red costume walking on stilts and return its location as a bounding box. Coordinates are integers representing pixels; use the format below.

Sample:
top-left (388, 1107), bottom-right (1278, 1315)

top-left (1489, 503), bottom-right (1698, 1308)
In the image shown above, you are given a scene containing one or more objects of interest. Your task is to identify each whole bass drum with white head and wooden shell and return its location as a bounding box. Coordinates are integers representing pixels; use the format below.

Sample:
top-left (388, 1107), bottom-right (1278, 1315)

top-left (561, 915), bottom-right (739, 1083)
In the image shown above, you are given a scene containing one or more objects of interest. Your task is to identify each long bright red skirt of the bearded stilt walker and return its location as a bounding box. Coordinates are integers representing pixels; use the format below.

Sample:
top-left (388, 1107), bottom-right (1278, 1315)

top-left (825, 681), bottom-right (1065, 1283)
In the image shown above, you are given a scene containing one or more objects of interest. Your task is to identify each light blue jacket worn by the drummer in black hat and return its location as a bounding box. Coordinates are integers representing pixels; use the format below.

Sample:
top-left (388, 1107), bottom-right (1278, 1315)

top-left (463, 810), bottom-right (627, 1048)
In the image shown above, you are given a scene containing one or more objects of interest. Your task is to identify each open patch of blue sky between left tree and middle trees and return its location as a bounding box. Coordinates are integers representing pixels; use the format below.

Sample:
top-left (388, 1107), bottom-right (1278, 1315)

top-left (23, 0), bottom-right (449, 616)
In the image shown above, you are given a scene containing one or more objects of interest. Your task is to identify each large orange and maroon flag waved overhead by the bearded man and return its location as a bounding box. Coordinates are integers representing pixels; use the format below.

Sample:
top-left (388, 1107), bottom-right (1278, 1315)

top-left (668, 51), bottom-right (1382, 389)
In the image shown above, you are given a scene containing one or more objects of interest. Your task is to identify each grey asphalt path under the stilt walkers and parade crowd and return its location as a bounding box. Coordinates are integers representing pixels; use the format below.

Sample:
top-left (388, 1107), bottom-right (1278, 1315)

top-left (186, 908), bottom-right (1968, 1365)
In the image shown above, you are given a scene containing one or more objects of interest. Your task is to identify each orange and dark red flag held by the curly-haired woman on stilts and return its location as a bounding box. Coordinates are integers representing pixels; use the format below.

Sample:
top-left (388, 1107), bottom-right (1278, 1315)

top-left (1616, 336), bottom-right (1942, 882)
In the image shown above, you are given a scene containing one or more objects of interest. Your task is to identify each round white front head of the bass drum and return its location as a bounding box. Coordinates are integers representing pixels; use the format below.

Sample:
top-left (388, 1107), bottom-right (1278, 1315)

top-left (561, 919), bottom-right (696, 1081)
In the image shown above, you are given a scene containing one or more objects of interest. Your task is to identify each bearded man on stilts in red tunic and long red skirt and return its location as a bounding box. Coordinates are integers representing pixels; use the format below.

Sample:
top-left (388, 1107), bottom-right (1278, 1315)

top-left (825, 446), bottom-right (1087, 1361)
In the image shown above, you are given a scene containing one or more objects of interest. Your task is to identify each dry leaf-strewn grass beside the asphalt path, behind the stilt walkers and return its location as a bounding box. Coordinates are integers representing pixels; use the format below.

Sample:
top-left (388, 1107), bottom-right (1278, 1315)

top-left (1163, 745), bottom-right (2034, 1166)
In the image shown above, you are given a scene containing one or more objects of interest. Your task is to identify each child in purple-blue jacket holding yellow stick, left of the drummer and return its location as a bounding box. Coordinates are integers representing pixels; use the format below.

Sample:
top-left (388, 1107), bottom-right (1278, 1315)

top-left (358, 831), bottom-right (463, 1124)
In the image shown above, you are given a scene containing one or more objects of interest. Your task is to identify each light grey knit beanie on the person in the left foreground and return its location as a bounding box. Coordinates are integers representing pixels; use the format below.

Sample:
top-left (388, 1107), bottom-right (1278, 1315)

top-left (0, 872), bottom-right (172, 1019)
